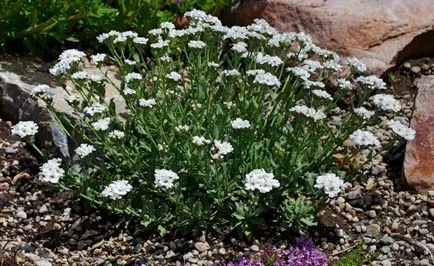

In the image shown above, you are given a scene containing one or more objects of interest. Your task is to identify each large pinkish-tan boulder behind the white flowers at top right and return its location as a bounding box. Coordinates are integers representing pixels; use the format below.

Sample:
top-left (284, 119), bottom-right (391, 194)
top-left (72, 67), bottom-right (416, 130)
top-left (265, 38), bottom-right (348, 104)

top-left (228, 0), bottom-right (434, 74)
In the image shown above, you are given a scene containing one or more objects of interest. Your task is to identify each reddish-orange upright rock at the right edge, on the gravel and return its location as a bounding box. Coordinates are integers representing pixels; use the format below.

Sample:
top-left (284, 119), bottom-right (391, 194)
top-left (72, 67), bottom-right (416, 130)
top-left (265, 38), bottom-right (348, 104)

top-left (404, 76), bottom-right (434, 193)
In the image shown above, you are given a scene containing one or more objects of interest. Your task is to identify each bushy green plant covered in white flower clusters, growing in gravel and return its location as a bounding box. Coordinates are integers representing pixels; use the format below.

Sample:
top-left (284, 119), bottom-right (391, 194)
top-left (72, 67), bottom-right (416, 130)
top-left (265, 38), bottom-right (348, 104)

top-left (30, 10), bottom-right (414, 236)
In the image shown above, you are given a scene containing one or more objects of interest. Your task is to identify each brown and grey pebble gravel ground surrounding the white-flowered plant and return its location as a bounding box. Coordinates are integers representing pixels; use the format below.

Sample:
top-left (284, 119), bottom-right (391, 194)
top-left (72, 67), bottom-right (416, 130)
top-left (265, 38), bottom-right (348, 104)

top-left (0, 60), bottom-right (434, 266)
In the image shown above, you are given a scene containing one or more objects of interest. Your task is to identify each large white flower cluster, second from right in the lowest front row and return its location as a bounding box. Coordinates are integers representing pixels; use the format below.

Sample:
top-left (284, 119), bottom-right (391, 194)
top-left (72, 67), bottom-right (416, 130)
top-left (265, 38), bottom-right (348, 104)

top-left (244, 169), bottom-right (280, 193)
